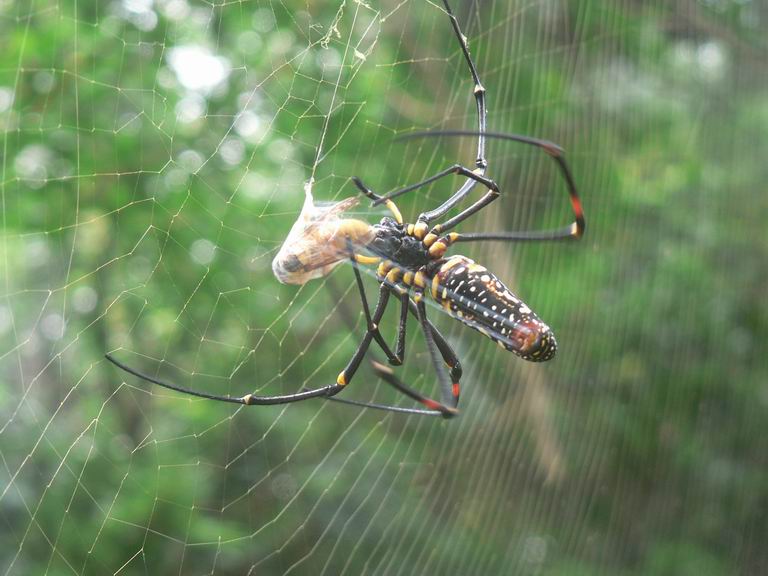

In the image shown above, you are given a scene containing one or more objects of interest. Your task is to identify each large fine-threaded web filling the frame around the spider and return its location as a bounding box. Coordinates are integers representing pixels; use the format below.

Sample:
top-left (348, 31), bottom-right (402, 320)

top-left (0, 0), bottom-right (768, 575)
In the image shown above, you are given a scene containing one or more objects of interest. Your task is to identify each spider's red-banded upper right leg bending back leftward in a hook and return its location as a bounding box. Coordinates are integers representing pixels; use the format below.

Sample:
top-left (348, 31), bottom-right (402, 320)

top-left (400, 130), bottom-right (586, 242)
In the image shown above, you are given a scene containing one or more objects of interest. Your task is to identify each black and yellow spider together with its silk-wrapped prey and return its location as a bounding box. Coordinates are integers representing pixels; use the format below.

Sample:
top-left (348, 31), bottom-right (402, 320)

top-left (106, 0), bottom-right (585, 418)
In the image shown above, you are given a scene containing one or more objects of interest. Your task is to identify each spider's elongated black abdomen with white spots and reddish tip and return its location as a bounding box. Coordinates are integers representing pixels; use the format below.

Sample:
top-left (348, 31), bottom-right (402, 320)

top-left (431, 256), bottom-right (557, 362)
